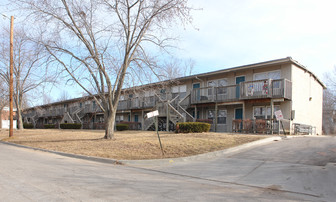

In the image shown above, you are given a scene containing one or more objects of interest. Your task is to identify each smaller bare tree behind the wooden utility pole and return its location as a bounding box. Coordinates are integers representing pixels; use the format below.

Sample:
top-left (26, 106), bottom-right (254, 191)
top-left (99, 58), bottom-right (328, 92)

top-left (0, 27), bottom-right (48, 129)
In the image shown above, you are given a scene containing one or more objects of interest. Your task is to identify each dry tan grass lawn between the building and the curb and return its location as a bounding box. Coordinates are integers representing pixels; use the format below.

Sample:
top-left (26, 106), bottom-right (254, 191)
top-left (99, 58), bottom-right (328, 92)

top-left (0, 129), bottom-right (267, 160)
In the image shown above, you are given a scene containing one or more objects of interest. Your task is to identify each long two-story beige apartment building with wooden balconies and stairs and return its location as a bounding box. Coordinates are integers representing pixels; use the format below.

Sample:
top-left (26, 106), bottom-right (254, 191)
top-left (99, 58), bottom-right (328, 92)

top-left (24, 57), bottom-right (325, 134)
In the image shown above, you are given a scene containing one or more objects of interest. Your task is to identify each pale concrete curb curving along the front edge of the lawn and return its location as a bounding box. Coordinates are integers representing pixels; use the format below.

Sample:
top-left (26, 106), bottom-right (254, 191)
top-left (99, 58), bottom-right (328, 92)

top-left (0, 136), bottom-right (283, 166)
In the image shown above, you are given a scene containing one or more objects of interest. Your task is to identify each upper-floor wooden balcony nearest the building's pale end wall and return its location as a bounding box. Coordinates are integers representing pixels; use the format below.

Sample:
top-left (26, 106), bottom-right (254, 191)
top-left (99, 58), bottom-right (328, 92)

top-left (191, 79), bottom-right (292, 104)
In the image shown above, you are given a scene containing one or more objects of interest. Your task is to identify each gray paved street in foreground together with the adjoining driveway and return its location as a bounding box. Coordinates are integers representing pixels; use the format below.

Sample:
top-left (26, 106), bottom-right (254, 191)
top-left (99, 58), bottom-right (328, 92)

top-left (0, 137), bottom-right (336, 201)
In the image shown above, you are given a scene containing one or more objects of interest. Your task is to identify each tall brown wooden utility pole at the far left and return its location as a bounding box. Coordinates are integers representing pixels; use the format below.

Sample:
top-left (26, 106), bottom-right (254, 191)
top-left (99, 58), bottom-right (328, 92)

top-left (9, 16), bottom-right (14, 137)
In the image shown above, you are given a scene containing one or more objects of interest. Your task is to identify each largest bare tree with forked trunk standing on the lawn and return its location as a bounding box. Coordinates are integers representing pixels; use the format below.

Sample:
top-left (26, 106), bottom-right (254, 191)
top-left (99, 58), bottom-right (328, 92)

top-left (13, 0), bottom-right (190, 139)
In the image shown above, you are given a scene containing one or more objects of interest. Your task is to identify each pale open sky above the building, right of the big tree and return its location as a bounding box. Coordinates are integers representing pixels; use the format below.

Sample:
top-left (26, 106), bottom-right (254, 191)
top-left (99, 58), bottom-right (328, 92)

top-left (179, 0), bottom-right (336, 79)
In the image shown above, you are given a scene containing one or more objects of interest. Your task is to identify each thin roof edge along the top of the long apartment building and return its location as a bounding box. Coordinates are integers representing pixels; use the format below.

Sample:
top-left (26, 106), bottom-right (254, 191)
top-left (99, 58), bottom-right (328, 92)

top-left (28, 57), bottom-right (326, 109)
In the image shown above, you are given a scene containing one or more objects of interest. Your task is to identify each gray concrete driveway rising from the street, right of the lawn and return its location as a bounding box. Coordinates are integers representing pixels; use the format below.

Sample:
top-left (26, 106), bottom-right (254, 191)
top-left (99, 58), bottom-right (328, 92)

top-left (146, 137), bottom-right (336, 201)
